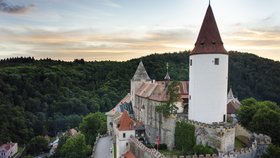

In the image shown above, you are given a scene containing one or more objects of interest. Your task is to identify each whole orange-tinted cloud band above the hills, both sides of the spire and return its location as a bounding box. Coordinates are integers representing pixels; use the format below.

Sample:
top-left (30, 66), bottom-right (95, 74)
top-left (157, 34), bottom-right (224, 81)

top-left (0, 26), bottom-right (280, 61)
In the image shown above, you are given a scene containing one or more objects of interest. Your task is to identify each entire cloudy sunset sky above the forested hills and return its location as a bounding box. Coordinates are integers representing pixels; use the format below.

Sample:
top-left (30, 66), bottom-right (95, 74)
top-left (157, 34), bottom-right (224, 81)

top-left (0, 0), bottom-right (280, 61)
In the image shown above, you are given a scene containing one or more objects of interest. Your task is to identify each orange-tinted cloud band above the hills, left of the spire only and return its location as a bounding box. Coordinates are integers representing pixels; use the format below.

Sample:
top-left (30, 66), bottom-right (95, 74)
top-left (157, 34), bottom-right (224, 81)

top-left (0, 27), bottom-right (193, 60)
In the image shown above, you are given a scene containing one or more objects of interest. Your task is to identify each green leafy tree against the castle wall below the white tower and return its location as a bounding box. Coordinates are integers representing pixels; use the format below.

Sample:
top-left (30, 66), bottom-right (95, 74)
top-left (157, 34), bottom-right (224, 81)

top-left (175, 121), bottom-right (195, 153)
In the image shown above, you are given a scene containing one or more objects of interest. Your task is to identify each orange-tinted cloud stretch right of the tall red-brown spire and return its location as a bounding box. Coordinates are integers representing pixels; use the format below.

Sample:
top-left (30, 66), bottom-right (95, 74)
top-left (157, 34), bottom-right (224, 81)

top-left (223, 26), bottom-right (280, 61)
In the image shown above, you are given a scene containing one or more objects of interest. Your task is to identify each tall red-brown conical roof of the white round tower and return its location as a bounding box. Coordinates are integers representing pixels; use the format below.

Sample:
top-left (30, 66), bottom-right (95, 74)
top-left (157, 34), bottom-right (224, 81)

top-left (190, 4), bottom-right (228, 55)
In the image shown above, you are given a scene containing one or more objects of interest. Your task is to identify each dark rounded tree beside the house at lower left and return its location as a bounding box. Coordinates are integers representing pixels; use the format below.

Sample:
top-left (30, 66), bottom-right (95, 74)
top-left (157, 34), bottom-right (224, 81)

top-left (27, 136), bottom-right (48, 156)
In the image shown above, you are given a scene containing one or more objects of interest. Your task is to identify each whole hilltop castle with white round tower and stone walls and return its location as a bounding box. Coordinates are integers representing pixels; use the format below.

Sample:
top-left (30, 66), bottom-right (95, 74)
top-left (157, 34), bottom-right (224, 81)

top-left (106, 4), bottom-right (271, 158)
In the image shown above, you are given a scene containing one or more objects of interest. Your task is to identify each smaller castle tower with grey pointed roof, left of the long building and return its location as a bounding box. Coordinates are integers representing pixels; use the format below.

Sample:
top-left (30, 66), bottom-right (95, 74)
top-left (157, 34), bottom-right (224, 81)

top-left (130, 61), bottom-right (151, 117)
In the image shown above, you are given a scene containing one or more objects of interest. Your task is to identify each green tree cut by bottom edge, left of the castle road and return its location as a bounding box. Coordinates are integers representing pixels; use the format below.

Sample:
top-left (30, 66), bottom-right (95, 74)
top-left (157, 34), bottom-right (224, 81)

top-left (60, 134), bottom-right (91, 158)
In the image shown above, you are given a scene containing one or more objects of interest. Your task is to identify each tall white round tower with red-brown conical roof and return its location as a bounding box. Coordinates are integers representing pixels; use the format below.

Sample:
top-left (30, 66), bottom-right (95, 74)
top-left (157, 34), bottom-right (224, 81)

top-left (189, 4), bottom-right (228, 123)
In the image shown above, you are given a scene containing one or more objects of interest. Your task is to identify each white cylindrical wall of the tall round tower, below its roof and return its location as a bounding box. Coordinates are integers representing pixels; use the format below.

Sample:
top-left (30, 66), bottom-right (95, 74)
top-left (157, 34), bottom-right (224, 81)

top-left (189, 54), bottom-right (228, 123)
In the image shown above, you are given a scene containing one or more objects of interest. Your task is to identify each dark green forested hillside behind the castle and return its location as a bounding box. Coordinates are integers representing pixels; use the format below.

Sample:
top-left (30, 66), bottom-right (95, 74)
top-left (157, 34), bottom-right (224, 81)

top-left (0, 51), bottom-right (280, 144)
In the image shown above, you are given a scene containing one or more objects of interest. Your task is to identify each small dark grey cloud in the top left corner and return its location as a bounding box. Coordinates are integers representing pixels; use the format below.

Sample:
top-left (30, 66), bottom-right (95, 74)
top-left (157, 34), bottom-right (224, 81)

top-left (0, 0), bottom-right (34, 14)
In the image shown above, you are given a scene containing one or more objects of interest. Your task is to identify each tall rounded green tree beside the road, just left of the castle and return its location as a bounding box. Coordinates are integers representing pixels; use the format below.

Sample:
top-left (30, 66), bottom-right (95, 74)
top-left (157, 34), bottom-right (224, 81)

top-left (80, 112), bottom-right (107, 145)
